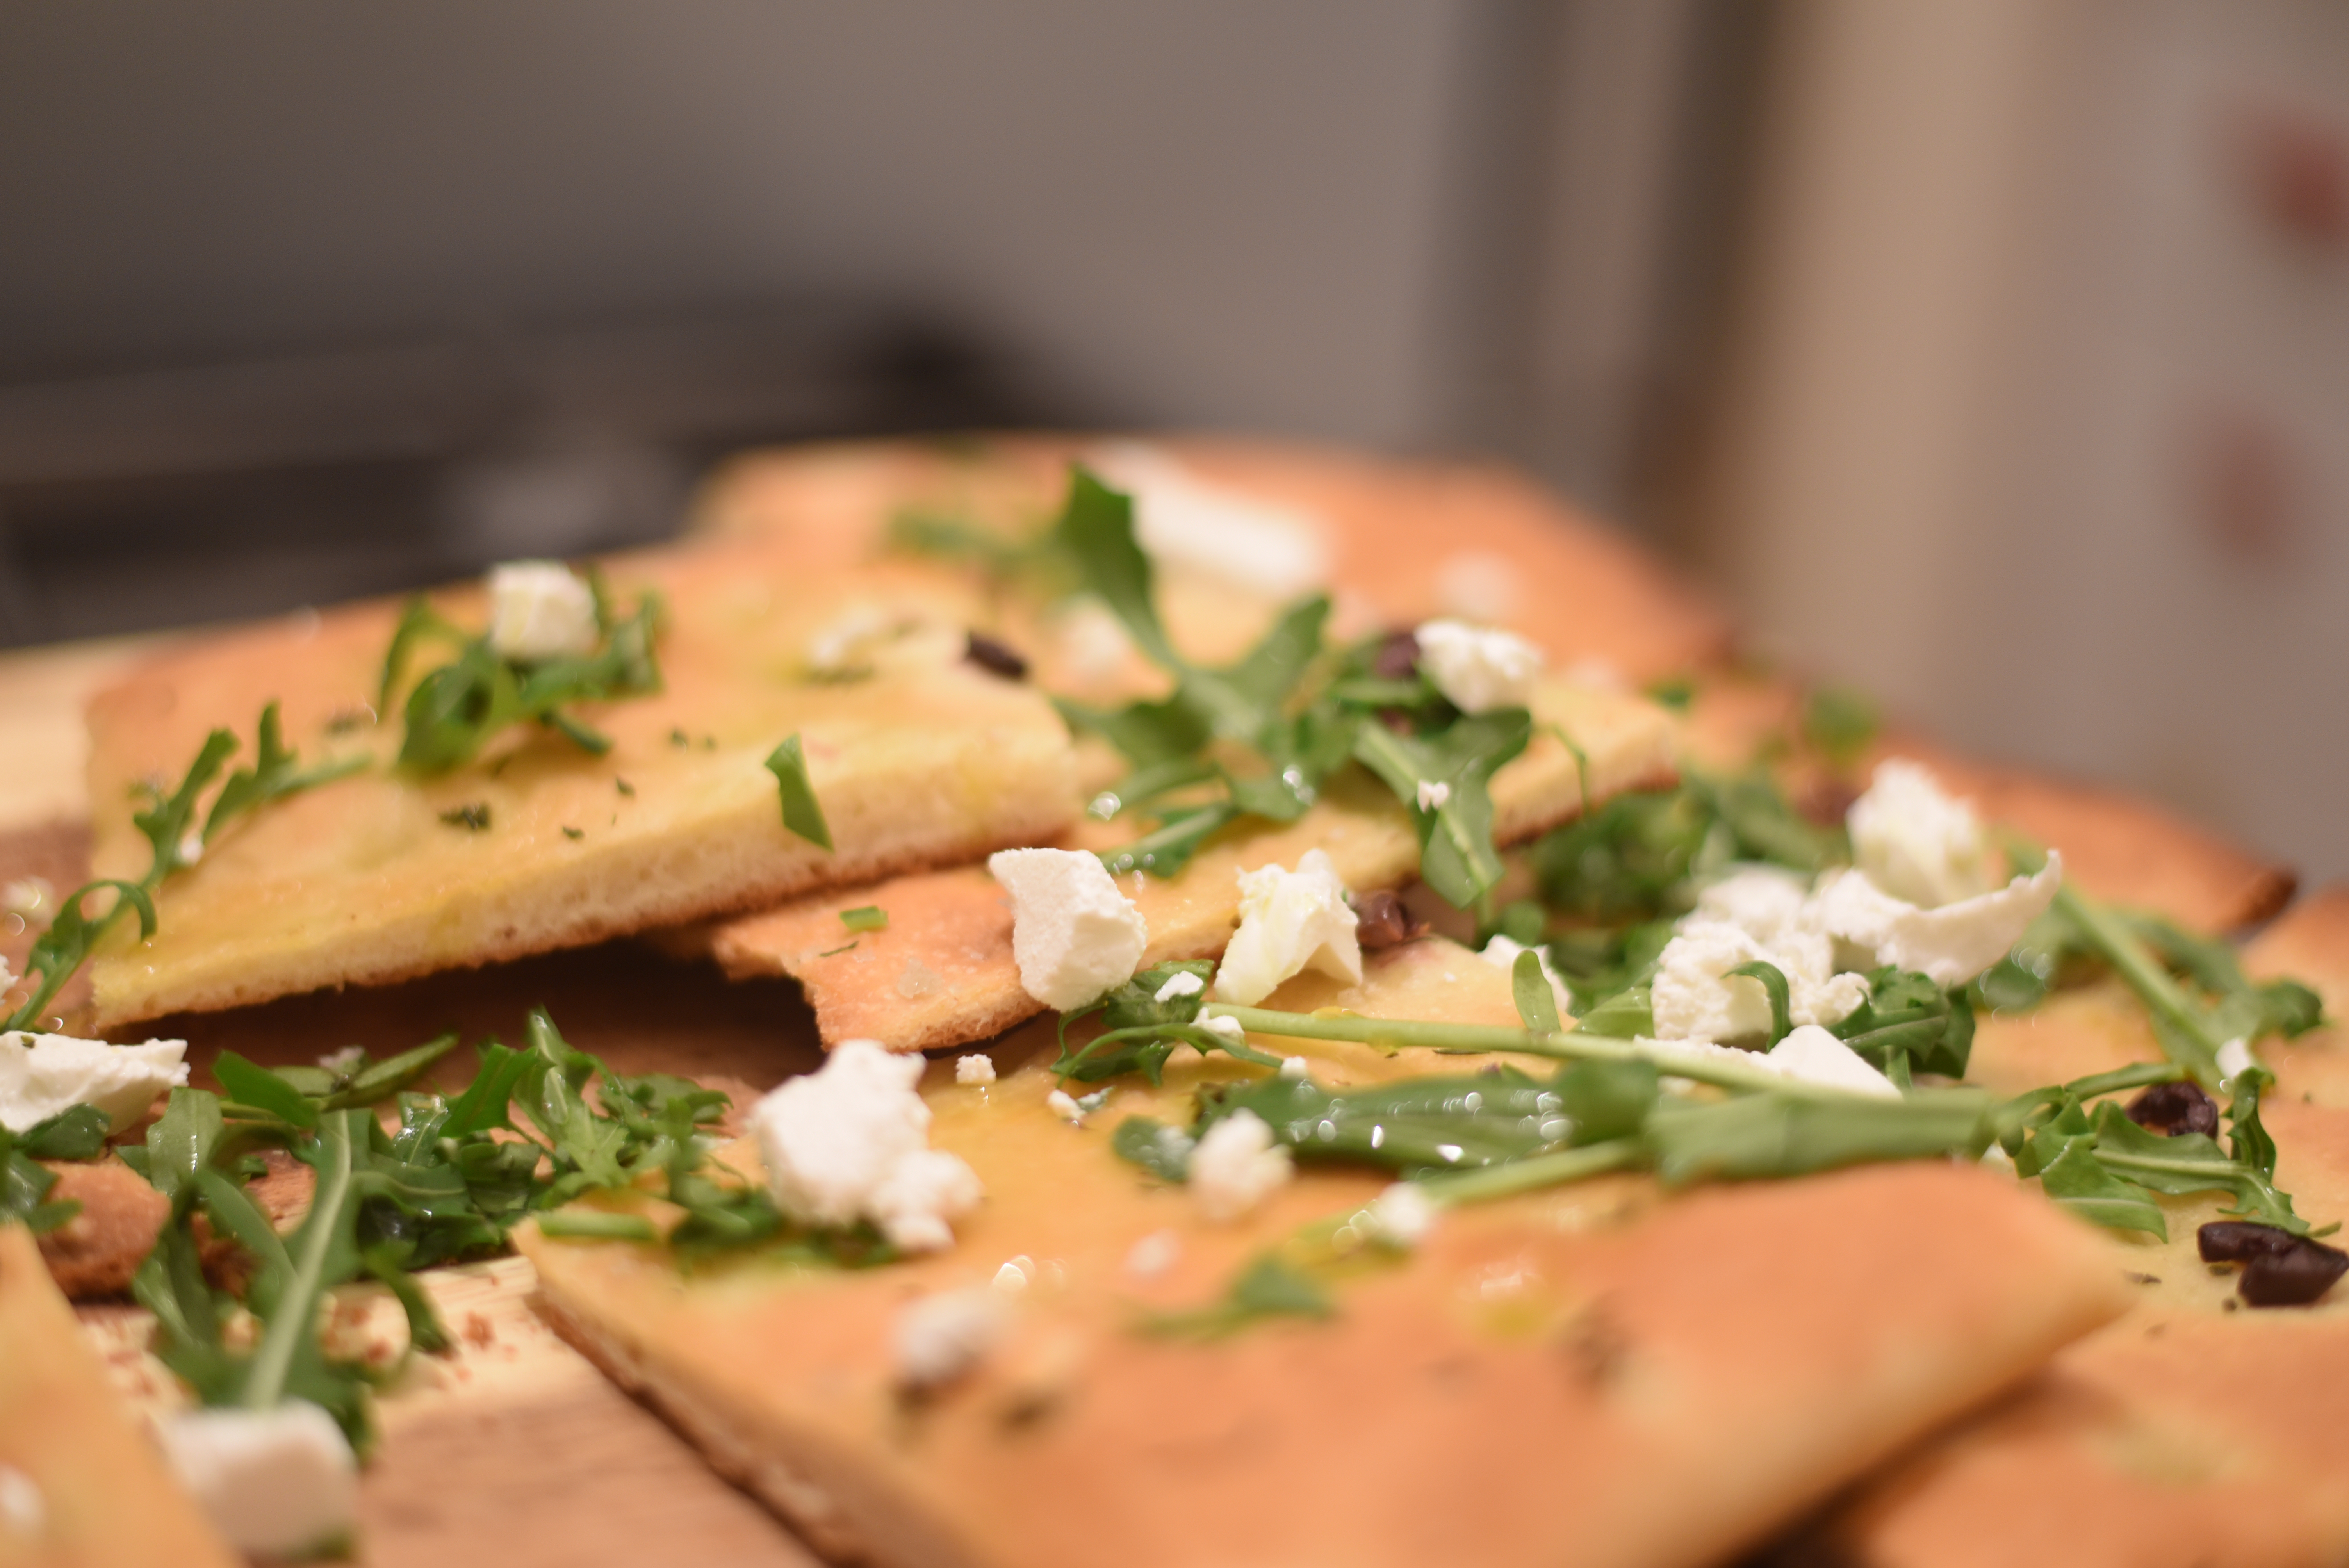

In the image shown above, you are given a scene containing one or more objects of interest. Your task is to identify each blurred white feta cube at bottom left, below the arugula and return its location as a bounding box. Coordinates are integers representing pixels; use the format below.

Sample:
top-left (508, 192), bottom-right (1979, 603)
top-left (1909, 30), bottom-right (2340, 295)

top-left (157, 1399), bottom-right (359, 1556)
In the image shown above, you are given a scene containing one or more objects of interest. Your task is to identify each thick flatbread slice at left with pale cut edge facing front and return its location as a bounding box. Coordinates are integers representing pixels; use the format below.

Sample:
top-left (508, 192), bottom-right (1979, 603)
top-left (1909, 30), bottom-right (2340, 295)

top-left (89, 545), bottom-right (1076, 1028)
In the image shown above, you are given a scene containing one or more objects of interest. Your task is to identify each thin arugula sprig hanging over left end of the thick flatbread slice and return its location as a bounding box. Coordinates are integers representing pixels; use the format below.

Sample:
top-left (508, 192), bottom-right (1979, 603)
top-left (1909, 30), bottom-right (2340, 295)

top-left (0, 702), bottom-right (366, 1030)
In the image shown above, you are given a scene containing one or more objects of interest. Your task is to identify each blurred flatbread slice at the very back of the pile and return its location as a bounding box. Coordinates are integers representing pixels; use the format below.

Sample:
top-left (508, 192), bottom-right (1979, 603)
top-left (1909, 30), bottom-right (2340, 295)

top-left (693, 434), bottom-right (1729, 683)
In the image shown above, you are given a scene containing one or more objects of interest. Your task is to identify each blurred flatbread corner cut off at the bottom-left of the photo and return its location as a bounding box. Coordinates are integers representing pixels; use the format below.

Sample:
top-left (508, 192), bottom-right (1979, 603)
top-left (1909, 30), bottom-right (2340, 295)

top-left (0, 1225), bottom-right (244, 1568)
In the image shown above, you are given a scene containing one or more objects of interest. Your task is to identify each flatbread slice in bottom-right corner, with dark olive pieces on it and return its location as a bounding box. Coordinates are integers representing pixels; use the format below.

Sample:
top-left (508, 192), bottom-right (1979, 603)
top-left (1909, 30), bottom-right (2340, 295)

top-left (1816, 887), bottom-right (2349, 1568)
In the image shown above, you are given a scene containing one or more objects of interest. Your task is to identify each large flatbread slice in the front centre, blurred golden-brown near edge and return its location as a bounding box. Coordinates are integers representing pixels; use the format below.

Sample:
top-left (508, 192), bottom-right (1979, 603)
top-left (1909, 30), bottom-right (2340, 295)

top-left (522, 939), bottom-right (2126, 1568)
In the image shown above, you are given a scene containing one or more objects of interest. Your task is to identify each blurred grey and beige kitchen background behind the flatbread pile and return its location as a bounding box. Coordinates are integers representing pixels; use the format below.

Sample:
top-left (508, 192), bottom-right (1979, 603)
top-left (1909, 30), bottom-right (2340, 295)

top-left (0, 0), bottom-right (2349, 875)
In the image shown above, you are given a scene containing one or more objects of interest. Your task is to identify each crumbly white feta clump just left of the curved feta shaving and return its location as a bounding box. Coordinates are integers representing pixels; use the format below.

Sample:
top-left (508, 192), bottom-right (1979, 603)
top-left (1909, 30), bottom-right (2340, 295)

top-left (1649, 916), bottom-right (1868, 1040)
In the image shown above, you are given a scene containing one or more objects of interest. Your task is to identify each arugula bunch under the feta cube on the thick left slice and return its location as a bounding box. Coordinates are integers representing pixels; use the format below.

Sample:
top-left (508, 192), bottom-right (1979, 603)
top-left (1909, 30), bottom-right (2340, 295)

top-left (376, 575), bottom-right (663, 775)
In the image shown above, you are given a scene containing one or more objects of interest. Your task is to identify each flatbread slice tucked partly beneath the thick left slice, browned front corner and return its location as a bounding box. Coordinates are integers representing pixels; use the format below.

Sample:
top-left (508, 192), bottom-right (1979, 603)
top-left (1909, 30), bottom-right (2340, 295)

top-left (691, 683), bottom-right (1672, 1051)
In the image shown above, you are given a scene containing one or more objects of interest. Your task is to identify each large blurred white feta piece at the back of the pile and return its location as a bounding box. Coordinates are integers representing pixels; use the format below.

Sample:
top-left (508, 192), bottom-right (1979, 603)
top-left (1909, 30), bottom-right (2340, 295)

top-left (1092, 441), bottom-right (1330, 599)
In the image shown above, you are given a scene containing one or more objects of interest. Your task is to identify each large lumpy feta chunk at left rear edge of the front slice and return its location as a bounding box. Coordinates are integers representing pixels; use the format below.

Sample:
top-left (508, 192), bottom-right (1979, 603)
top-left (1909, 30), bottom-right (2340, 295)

top-left (749, 1040), bottom-right (982, 1251)
